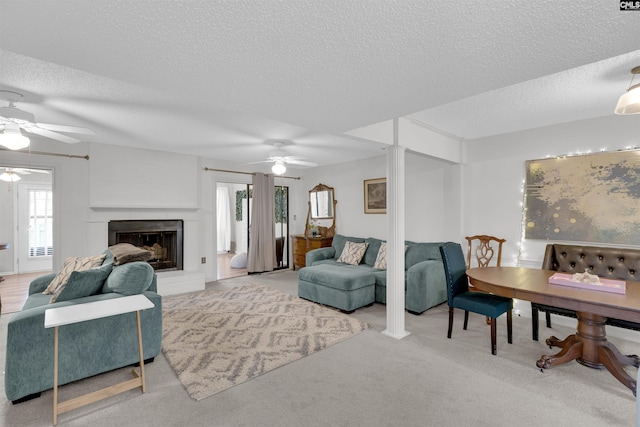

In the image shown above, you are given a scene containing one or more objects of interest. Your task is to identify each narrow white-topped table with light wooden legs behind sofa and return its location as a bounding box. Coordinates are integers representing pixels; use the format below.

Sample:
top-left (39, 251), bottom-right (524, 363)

top-left (44, 294), bottom-right (154, 426)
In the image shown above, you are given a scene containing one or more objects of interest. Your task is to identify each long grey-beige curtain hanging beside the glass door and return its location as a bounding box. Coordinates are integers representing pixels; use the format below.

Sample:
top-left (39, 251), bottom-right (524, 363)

top-left (247, 173), bottom-right (276, 273)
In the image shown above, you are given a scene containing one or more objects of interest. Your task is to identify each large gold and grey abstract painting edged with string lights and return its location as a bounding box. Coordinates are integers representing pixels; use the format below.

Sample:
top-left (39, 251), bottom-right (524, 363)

top-left (524, 149), bottom-right (640, 245)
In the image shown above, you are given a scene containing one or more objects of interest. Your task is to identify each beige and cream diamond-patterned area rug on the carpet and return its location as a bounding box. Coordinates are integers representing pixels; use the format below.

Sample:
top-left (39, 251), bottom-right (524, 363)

top-left (162, 285), bottom-right (369, 400)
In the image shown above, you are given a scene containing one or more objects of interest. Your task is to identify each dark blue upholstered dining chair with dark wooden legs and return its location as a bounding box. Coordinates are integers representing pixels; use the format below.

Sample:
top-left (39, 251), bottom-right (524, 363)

top-left (440, 243), bottom-right (513, 354)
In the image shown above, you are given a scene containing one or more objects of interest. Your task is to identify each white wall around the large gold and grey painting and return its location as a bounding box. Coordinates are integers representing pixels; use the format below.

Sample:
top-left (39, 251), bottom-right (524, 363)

top-left (460, 116), bottom-right (640, 267)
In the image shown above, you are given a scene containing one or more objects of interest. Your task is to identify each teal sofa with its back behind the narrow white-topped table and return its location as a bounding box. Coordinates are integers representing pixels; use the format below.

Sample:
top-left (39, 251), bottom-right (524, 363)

top-left (4, 250), bottom-right (162, 403)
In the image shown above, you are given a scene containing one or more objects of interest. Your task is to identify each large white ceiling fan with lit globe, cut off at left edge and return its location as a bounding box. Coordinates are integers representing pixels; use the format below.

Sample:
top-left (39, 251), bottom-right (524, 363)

top-left (0, 90), bottom-right (95, 150)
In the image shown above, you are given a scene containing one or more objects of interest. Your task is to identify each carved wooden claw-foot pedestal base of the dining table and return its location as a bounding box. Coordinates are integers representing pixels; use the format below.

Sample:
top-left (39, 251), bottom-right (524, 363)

top-left (536, 312), bottom-right (640, 395)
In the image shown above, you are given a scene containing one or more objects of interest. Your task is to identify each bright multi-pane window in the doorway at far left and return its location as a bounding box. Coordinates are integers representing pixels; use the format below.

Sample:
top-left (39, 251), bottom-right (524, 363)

top-left (28, 190), bottom-right (53, 257)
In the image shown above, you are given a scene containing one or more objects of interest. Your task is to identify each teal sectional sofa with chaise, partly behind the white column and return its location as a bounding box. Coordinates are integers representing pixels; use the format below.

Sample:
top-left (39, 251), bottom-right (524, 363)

top-left (298, 234), bottom-right (447, 314)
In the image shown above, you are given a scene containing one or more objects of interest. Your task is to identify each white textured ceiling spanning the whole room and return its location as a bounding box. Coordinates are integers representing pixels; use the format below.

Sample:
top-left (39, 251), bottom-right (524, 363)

top-left (0, 0), bottom-right (640, 169)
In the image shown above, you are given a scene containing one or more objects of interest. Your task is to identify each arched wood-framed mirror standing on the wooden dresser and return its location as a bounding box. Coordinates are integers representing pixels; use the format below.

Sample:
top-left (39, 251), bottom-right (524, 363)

top-left (305, 184), bottom-right (337, 237)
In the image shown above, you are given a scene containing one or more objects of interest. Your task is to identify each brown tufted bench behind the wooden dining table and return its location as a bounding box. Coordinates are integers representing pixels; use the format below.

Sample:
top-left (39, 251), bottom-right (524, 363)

top-left (531, 244), bottom-right (640, 341)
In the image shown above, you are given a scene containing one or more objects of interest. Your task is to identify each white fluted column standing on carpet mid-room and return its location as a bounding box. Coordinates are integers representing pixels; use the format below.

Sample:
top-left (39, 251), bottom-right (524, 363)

top-left (382, 119), bottom-right (409, 339)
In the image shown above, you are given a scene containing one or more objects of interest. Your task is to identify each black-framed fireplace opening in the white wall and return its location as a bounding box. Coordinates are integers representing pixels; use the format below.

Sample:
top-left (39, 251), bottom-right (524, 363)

top-left (109, 220), bottom-right (183, 271)
